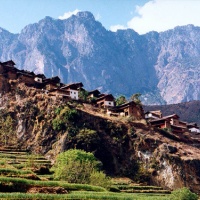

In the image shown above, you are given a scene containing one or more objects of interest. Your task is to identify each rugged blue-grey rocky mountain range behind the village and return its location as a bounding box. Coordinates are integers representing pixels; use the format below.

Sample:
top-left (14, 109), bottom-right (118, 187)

top-left (0, 12), bottom-right (200, 104)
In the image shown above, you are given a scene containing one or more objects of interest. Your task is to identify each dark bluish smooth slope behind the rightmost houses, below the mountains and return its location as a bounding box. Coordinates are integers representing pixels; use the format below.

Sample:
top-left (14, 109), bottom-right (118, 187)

top-left (143, 101), bottom-right (200, 126)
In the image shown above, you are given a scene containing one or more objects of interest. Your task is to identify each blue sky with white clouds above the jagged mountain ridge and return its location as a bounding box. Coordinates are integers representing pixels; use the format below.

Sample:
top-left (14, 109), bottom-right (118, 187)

top-left (0, 0), bottom-right (200, 34)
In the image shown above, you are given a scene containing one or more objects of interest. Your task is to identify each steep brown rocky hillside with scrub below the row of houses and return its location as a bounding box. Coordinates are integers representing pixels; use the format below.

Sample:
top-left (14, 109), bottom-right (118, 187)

top-left (0, 69), bottom-right (200, 193)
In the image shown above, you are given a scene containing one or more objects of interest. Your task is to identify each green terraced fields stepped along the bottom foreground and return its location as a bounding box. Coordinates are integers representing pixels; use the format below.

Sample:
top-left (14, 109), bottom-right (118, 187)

top-left (0, 148), bottom-right (178, 200)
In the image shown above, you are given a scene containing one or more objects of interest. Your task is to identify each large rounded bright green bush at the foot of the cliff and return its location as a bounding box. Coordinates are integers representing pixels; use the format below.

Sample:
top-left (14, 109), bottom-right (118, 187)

top-left (53, 149), bottom-right (104, 183)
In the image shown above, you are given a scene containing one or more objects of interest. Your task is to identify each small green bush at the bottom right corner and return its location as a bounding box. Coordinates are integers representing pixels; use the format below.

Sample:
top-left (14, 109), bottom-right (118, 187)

top-left (171, 187), bottom-right (198, 200)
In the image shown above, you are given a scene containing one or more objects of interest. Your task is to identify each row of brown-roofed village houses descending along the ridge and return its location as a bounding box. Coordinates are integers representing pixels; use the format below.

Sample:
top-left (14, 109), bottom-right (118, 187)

top-left (0, 60), bottom-right (200, 134)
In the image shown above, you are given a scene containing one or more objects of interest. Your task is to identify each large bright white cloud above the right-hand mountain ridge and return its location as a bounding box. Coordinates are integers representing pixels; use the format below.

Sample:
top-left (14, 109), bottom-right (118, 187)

top-left (127, 0), bottom-right (200, 34)
